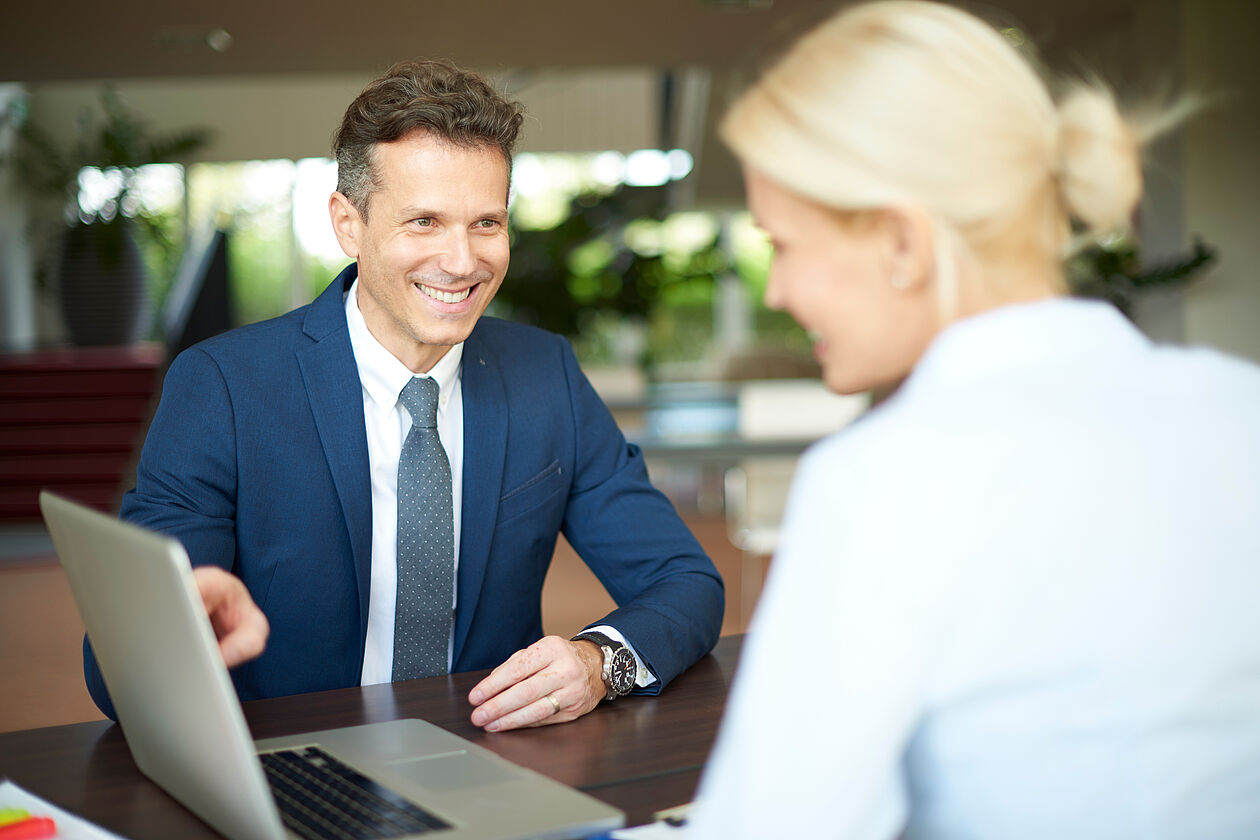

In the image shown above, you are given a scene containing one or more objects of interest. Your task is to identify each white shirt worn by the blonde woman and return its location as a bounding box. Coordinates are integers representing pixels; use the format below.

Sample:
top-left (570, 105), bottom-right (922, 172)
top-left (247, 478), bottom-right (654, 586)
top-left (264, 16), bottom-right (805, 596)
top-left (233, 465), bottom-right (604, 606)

top-left (689, 300), bottom-right (1260, 840)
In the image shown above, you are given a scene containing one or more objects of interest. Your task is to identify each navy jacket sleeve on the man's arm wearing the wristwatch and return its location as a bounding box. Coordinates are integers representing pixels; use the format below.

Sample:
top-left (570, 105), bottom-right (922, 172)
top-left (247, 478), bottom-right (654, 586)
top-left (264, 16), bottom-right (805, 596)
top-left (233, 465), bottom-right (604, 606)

top-left (558, 339), bottom-right (725, 694)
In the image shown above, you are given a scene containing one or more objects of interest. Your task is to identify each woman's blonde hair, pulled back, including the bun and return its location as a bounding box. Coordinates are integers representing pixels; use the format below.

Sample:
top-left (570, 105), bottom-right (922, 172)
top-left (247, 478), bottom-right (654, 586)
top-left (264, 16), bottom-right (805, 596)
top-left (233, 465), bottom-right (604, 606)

top-left (721, 0), bottom-right (1168, 280)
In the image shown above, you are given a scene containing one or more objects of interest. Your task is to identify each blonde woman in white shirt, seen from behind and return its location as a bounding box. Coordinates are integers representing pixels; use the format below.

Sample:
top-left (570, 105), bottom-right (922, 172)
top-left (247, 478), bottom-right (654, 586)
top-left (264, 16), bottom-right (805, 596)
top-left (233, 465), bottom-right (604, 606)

top-left (692, 0), bottom-right (1260, 840)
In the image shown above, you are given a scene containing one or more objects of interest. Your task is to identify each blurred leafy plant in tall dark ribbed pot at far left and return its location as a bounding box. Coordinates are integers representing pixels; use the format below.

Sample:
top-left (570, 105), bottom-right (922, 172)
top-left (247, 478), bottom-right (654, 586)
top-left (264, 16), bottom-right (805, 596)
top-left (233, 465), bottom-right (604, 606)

top-left (9, 87), bottom-right (209, 346)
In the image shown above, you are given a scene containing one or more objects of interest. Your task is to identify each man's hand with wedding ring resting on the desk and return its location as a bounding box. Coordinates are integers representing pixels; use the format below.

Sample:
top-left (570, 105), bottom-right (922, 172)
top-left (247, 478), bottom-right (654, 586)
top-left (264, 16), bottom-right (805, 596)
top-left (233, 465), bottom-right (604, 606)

top-left (469, 636), bottom-right (606, 732)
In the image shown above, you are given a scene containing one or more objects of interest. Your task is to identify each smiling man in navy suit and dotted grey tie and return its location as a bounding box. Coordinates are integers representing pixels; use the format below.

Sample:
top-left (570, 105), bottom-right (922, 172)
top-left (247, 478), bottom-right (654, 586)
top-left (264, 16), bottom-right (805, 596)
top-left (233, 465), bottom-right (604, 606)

top-left (84, 62), bottom-right (723, 730)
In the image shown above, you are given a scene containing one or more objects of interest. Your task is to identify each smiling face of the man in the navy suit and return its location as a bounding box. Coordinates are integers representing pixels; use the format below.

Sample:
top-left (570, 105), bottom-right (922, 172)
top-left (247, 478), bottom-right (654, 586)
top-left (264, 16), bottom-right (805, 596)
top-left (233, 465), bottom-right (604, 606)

top-left (329, 131), bottom-right (508, 373)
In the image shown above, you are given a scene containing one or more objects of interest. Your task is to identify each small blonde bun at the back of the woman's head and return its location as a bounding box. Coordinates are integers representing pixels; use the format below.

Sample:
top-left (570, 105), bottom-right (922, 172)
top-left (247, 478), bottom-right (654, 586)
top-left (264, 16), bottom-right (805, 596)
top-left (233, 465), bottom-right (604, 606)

top-left (1058, 83), bottom-right (1142, 233)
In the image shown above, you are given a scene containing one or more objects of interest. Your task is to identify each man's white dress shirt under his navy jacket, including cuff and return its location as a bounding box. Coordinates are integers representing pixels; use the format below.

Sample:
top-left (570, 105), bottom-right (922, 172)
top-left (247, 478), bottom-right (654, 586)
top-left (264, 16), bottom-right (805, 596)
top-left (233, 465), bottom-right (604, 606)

top-left (345, 280), bottom-right (656, 688)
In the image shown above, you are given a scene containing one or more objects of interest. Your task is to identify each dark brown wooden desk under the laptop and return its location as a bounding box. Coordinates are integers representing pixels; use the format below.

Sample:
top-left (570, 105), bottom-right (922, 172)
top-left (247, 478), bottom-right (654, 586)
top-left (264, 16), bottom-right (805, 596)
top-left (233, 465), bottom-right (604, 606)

top-left (0, 636), bottom-right (742, 840)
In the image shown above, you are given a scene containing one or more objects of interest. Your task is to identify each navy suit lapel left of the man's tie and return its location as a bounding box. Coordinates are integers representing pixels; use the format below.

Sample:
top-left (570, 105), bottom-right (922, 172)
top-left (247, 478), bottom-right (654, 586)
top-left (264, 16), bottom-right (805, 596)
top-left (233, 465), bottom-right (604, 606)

top-left (297, 264), bottom-right (372, 635)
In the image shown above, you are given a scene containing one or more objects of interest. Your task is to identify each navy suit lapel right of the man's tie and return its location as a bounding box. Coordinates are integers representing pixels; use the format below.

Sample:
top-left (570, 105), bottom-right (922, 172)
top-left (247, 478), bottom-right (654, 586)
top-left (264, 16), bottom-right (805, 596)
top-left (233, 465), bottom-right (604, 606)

top-left (452, 329), bottom-right (508, 662)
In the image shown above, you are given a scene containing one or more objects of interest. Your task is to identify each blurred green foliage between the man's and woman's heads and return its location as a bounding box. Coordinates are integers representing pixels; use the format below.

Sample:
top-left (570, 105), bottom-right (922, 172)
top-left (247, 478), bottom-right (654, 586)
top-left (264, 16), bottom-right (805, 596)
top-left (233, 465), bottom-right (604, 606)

top-left (494, 188), bottom-right (809, 369)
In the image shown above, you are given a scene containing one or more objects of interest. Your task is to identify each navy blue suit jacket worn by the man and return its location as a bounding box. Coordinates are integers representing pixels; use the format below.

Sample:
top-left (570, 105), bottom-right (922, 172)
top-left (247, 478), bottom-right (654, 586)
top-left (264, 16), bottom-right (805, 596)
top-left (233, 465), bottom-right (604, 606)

top-left (84, 264), bottom-right (723, 717)
